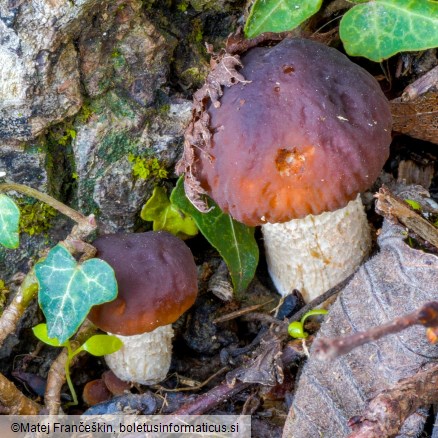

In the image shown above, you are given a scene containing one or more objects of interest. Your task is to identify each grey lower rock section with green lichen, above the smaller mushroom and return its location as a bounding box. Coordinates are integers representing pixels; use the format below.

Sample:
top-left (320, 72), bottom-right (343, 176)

top-left (73, 93), bottom-right (191, 231)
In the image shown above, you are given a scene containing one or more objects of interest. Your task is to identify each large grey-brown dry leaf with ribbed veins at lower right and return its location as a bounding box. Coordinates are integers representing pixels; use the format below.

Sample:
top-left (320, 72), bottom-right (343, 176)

top-left (284, 186), bottom-right (438, 438)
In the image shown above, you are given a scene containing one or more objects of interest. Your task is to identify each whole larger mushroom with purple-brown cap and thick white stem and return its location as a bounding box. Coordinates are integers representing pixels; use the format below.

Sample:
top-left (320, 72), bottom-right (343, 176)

top-left (186, 39), bottom-right (392, 300)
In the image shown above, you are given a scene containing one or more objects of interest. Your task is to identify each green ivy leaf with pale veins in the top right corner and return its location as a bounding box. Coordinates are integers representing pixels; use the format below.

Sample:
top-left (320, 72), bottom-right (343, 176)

top-left (339, 0), bottom-right (438, 62)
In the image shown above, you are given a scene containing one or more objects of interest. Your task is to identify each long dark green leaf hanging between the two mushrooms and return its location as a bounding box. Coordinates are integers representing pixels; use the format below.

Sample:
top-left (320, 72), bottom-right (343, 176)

top-left (170, 177), bottom-right (259, 293)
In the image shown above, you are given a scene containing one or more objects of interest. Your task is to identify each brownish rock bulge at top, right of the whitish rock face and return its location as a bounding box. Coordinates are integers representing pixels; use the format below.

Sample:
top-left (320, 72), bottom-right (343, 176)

top-left (79, 0), bottom-right (177, 106)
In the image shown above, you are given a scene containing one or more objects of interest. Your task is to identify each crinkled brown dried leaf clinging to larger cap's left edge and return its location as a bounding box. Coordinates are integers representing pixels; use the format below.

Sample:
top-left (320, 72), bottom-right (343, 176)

top-left (175, 47), bottom-right (248, 213)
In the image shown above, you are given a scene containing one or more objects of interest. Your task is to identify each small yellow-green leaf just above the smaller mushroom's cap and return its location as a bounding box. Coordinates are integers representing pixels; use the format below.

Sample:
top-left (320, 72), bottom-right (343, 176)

top-left (140, 187), bottom-right (198, 239)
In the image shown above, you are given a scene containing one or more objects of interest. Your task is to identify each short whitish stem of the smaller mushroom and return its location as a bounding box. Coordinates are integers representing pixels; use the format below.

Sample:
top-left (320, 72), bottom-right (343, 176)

top-left (105, 324), bottom-right (173, 385)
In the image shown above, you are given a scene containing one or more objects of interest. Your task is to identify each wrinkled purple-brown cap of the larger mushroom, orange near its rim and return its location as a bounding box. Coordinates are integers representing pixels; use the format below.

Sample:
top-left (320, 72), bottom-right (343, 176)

top-left (193, 38), bottom-right (392, 226)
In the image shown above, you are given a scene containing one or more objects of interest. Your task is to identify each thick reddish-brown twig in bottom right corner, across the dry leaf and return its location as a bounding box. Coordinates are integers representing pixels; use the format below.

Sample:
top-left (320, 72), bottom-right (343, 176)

top-left (348, 365), bottom-right (438, 438)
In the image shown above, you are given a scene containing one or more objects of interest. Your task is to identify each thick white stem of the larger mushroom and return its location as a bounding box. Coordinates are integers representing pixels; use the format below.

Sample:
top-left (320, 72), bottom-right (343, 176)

top-left (262, 196), bottom-right (371, 302)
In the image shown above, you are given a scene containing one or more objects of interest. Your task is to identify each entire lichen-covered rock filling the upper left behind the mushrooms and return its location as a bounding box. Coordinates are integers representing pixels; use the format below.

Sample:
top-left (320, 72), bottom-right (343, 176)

top-left (0, 0), bottom-right (235, 231)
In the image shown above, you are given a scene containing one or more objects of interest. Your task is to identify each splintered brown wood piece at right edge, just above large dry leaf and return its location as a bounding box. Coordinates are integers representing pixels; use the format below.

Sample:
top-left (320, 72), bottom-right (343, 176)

top-left (375, 187), bottom-right (438, 248)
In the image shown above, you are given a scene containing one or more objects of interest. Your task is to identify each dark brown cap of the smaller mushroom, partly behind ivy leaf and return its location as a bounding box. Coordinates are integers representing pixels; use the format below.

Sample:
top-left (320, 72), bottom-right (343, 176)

top-left (88, 231), bottom-right (198, 336)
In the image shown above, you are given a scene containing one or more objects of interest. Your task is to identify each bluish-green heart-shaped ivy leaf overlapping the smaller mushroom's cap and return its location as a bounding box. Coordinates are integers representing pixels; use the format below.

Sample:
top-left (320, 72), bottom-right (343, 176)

top-left (35, 244), bottom-right (117, 344)
